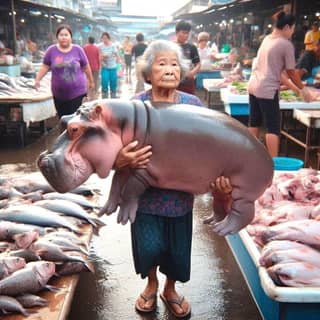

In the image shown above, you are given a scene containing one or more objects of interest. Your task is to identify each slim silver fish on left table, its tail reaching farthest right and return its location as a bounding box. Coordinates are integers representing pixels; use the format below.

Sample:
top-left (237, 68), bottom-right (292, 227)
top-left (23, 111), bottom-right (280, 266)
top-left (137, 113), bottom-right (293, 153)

top-left (34, 199), bottom-right (105, 228)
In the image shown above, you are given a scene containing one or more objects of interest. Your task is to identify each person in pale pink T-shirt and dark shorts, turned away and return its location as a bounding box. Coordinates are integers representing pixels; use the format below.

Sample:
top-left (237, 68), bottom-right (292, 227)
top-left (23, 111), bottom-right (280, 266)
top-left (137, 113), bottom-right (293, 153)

top-left (248, 11), bottom-right (311, 157)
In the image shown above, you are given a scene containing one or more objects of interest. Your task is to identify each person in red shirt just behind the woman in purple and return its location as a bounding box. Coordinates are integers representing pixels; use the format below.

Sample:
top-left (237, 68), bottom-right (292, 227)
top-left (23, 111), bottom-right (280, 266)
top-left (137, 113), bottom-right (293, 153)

top-left (83, 36), bottom-right (100, 100)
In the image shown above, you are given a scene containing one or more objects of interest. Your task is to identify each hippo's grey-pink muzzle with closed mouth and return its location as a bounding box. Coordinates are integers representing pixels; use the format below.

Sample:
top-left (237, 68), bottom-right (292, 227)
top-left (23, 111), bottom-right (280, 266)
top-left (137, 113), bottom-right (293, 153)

top-left (37, 151), bottom-right (93, 193)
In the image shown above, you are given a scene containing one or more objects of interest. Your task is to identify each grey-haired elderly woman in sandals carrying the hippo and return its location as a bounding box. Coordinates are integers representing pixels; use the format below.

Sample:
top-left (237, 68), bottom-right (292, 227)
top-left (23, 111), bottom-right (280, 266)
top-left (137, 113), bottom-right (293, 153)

top-left (116, 40), bottom-right (230, 317)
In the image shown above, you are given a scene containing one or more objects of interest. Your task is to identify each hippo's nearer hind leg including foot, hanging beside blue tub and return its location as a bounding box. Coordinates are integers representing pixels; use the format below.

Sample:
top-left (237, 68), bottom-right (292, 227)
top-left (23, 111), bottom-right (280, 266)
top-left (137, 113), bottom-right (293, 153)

top-left (213, 198), bottom-right (254, 236)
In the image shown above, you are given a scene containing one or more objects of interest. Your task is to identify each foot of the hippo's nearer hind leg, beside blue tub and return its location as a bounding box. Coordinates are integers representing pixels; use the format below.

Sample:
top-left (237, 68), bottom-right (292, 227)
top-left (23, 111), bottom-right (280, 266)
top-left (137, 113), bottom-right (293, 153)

top-left (212, 211), bottom-right (252, 236)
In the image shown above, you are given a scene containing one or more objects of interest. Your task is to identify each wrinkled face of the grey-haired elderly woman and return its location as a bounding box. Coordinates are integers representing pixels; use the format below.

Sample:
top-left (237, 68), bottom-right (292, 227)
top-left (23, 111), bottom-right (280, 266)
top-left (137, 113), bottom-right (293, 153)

top-left (149, 52), bottom-right (181, 89)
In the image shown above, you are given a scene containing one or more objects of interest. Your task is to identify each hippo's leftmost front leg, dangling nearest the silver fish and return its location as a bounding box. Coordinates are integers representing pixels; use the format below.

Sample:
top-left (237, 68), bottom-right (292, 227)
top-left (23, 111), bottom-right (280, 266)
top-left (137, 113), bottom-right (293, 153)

top-left (98, 169), bottom-right (130, 216)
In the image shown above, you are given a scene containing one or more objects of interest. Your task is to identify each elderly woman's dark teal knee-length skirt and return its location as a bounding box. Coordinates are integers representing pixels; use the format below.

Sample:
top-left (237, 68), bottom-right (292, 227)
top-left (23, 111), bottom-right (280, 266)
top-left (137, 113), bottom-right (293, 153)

top-left (131, 211), bottom-right (192, 282)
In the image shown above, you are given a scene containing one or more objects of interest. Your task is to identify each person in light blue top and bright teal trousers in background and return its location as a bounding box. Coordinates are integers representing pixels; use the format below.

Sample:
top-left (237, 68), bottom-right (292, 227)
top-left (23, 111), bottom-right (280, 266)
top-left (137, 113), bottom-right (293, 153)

top-left (99, 32), bottom-right (121, 99)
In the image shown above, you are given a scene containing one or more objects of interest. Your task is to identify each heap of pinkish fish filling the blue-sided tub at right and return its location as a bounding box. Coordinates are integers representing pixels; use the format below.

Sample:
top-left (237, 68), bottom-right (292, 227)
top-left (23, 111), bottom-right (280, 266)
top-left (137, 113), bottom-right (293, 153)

top-left (246, 169), bottom-right (320, 287)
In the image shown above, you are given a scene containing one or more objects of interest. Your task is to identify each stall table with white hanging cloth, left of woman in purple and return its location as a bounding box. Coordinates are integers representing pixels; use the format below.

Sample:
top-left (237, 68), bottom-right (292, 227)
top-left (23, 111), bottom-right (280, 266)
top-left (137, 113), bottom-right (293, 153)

top-left (0, 94), bottom-right (56, 146)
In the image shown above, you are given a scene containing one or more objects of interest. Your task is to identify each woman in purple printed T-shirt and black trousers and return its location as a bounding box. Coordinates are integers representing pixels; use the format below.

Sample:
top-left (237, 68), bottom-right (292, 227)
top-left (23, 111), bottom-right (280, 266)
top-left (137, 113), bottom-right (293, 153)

top-left (35, 25), bottom-right (94, 118)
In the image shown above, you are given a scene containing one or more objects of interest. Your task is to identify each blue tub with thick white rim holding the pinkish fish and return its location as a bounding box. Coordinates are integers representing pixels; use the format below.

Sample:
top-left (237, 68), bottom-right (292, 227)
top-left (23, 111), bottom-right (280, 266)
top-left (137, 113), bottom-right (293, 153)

top-left (226, 229), bottom-right (320, 320)
